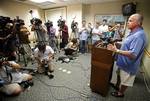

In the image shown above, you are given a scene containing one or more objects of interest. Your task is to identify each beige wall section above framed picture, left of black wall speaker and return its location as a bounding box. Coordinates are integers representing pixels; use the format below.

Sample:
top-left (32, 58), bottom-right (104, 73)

top-left (85, 2), bottom-right (123, 23)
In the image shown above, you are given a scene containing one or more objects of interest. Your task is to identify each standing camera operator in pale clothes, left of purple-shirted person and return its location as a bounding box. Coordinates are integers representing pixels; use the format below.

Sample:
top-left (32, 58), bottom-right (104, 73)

top-left (31, 18), bottom-right (47, 42)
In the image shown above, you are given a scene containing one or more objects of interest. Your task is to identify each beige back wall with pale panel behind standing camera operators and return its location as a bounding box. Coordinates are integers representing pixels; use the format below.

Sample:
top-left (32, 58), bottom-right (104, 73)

top-left (45, 4), bottom-right (82, 35)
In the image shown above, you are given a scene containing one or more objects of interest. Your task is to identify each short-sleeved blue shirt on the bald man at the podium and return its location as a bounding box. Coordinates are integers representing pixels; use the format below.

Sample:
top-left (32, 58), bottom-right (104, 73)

top-left (117, 28), bottom-right (146, 75)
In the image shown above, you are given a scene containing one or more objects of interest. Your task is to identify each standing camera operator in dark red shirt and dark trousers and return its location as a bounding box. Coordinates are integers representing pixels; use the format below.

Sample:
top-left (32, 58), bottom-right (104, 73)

top-left (59, 20), bottom-right (69, 49)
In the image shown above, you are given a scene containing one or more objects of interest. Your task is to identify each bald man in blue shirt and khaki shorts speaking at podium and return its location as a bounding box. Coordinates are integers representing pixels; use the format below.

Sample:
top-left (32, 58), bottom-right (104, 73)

top-left (107, 14), bottom-right (146, 97)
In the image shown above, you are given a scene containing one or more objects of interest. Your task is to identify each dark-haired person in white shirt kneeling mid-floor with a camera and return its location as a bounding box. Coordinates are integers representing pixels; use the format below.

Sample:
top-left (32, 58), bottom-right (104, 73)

top-left (34, 42), bottom-right (54, 78)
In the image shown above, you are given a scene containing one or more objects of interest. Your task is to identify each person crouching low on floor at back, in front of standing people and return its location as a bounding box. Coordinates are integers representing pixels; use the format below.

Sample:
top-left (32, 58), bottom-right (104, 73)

top-left (64, 38), bottom-right (78, 55)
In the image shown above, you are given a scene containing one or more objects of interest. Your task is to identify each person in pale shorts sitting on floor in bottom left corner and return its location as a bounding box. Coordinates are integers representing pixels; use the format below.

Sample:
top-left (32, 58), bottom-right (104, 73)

top-left (0, 58), bottom-right (33, 96)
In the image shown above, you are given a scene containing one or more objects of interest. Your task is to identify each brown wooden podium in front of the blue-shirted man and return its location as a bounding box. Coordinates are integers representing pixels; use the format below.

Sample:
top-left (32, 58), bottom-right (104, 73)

top-left (90, 46), bottom-right (113, 96)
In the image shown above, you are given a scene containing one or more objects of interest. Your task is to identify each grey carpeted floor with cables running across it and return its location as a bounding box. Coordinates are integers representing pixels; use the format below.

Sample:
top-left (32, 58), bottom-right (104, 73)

top-left (0, 53), bottom-right (150, 101)
